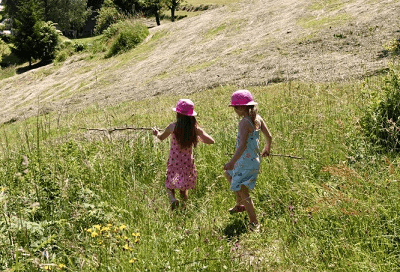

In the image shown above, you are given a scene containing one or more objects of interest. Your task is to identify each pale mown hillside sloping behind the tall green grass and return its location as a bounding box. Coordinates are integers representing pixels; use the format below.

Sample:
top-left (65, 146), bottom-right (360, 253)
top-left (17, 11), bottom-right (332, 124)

top-left (0, 0), bottom-right (400, 123)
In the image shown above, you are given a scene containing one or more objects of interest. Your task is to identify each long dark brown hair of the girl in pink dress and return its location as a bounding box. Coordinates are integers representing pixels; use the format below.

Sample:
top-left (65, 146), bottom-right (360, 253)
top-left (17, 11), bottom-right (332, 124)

top-left (174, 112), bottom-right (198, 149)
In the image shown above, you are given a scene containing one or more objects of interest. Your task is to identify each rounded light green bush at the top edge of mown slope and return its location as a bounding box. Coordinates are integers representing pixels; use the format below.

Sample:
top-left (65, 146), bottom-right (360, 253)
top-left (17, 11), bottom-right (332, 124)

top-left (105, 21), bottom-right (149, 57)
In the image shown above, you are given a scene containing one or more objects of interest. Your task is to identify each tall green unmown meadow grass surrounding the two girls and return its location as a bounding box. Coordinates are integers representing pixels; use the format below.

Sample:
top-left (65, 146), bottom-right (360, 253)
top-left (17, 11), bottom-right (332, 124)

top-left (0, 75), bottom-right (400, 271)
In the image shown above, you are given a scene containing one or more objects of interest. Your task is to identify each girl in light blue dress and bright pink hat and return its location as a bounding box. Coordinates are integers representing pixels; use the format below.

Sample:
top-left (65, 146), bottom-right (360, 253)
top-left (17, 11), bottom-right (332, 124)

top-left (224, 90), bottom-right (272, 228)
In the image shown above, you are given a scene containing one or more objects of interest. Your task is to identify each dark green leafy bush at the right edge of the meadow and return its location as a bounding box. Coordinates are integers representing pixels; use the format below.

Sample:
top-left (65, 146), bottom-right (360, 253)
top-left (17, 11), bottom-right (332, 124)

top-left (361, 67), bottom-right (400, 151)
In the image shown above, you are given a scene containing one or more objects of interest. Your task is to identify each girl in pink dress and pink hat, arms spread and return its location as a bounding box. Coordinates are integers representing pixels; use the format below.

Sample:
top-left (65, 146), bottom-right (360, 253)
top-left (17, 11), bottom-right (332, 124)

top-left (153, 99), bottom-right (214, 210)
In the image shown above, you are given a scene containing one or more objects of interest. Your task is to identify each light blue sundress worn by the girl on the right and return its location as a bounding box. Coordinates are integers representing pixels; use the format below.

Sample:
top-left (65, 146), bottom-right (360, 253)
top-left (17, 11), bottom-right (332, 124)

top-left (228, 117), bottom-right (261, 191)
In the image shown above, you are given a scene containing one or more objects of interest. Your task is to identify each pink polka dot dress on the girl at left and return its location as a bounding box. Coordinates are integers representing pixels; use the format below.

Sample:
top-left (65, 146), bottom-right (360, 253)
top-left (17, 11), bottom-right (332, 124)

top-left (165, 133), bottom-right (197, 191)
